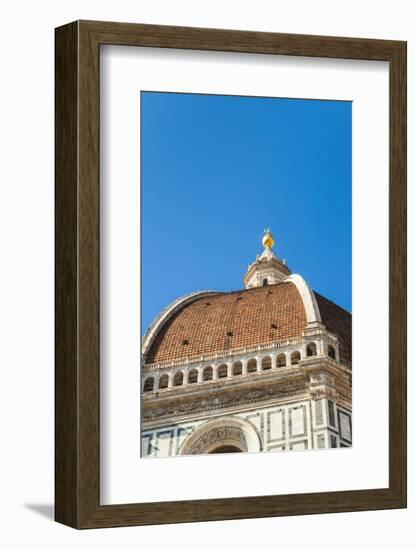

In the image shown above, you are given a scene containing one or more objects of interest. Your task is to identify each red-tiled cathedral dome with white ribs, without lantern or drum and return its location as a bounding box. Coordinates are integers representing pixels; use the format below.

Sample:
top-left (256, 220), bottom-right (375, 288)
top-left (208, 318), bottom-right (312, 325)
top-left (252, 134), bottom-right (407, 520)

top-left (144, 276), bottom-right (351, 364)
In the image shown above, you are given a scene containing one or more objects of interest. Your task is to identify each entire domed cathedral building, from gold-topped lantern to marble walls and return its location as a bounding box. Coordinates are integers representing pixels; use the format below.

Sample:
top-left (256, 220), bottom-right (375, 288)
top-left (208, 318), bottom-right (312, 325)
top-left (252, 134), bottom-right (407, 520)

top-left (141, 229), bottom-right (352, 458)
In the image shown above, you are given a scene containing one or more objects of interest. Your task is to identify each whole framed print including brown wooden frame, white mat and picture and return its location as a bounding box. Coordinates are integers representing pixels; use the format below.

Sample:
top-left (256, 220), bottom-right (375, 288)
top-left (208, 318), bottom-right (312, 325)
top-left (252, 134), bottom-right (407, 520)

top-left (55, 21), bottom-right (406, 528)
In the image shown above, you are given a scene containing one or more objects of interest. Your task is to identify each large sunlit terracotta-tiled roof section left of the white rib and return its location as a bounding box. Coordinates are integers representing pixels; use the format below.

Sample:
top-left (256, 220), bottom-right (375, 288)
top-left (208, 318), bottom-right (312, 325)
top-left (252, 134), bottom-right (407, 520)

top-left (146, 283), bottom-right (307, 363)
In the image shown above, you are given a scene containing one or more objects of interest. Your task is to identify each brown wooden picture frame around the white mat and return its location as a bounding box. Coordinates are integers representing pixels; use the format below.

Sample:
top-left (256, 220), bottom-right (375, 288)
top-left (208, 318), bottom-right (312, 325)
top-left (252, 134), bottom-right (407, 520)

top-left (55, 21), bottom-right (407, 528)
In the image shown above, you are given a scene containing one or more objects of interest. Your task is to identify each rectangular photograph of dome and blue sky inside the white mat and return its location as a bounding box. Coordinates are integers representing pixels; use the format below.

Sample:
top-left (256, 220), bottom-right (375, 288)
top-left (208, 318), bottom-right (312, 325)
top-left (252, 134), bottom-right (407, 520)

top-left (138, 90), bottom-right (353, 458)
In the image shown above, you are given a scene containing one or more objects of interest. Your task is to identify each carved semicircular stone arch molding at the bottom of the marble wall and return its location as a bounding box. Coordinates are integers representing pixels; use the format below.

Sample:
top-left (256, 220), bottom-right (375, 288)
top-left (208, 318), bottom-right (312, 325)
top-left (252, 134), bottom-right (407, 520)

top-left (179, 417), bottom-right (261, 455)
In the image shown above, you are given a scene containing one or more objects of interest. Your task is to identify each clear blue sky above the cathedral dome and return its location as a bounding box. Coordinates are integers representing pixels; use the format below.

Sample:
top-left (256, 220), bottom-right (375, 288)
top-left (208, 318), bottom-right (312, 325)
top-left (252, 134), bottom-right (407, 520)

top-left (141, 92), bottom-right (352, 333)
